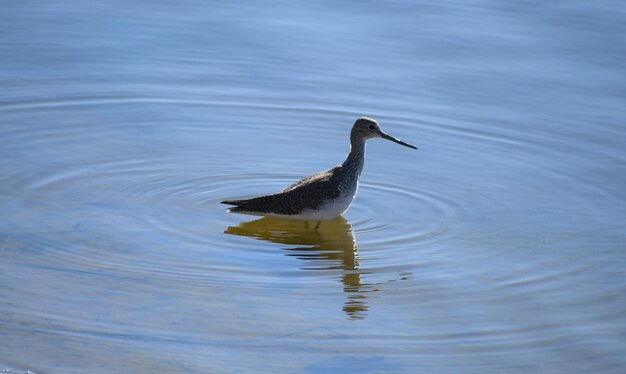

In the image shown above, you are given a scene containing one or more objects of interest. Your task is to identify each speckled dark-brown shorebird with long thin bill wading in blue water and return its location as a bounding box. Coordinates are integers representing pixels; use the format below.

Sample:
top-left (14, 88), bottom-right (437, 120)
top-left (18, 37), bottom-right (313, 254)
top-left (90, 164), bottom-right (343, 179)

top-left (222, 117), bottom-right (417, 222)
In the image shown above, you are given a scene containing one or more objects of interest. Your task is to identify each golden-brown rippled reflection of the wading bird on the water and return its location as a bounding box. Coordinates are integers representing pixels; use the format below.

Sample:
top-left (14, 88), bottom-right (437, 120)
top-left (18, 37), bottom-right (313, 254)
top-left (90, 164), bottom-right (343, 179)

top-left (224, 216), bottom-right (372, 319)
